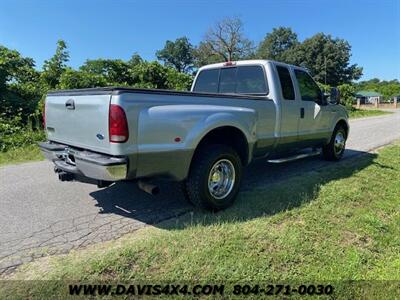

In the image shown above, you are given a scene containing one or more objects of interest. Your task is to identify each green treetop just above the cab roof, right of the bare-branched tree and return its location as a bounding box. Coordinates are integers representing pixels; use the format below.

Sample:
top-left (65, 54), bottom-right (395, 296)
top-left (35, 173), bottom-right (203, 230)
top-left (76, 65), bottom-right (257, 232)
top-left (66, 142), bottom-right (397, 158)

top-left (257, 27), bottom-right (299, 62)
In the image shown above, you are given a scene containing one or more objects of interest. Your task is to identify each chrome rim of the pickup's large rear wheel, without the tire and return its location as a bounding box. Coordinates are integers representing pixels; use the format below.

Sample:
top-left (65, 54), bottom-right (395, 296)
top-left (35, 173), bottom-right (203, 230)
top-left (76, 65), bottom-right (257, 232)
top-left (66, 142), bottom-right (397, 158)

top-left (208, 159), bottom-right (236, 199)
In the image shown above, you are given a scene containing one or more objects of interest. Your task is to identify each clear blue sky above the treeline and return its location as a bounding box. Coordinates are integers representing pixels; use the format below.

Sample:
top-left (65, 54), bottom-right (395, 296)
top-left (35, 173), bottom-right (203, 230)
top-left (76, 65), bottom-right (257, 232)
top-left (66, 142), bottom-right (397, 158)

top-left (0, 0), bottom-right (400, 80)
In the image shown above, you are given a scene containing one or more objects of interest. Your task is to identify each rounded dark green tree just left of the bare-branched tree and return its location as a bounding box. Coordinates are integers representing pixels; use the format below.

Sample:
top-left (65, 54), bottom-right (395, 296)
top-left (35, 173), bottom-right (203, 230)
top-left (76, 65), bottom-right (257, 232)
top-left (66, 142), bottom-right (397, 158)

top-left (156, 37), bottom-right (194, 72)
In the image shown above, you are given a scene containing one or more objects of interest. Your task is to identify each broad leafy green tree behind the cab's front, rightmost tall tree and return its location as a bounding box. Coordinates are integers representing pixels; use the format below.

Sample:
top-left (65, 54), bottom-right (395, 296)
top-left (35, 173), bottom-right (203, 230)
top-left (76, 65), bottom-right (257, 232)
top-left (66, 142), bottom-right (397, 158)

top-left (284, 33), bottom-right (362, 86)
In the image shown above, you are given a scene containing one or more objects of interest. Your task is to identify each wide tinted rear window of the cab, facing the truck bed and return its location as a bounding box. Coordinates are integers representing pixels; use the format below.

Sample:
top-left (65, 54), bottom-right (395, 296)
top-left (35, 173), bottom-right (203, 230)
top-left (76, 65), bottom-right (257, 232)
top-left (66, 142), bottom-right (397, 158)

top-left (193, 66), bottom-right (268, 96)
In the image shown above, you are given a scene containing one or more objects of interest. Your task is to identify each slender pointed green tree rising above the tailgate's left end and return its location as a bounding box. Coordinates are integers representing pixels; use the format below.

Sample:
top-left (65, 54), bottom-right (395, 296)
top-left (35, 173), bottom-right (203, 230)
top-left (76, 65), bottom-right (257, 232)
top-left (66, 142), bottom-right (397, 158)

top-left (41, 40), bottom-right (69, 89)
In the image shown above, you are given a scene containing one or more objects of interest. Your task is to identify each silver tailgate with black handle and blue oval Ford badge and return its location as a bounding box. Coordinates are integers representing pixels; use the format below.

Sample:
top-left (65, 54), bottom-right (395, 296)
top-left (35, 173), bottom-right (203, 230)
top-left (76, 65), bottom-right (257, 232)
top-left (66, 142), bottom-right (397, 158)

top-left (45, 94), bottom-right (111, 153)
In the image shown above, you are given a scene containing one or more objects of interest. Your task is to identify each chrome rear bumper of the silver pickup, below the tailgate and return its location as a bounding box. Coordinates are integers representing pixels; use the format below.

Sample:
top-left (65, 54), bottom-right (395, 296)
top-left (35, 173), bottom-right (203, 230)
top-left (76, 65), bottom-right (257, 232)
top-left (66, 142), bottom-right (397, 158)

top-left (39, 142), bottom-right (128, 181)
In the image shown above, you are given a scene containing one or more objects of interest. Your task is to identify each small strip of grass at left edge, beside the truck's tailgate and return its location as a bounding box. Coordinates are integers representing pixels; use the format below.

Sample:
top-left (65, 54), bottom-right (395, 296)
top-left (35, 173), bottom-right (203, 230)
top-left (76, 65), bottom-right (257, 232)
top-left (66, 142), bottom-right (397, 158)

top-left (0, 145), bottom-right (44, 166)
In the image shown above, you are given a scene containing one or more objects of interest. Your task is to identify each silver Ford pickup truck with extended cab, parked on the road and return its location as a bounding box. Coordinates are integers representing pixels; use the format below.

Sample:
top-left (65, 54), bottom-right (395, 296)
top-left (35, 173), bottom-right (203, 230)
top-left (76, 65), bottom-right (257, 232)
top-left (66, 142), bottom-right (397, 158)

top-left (40, 60), bottom-right (349, 210)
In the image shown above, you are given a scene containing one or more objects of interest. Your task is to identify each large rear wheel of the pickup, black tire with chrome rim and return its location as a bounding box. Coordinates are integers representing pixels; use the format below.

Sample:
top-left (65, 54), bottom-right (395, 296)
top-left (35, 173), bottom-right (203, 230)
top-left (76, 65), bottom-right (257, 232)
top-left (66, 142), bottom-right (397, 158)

top-left (186, 145), bottom-right (242, 211)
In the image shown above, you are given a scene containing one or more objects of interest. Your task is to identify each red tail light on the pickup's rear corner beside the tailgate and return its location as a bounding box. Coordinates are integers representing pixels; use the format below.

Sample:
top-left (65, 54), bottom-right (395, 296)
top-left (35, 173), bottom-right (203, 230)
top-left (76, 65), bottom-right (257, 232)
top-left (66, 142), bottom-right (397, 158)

top-left (108, 104), bottom-right (129, 143)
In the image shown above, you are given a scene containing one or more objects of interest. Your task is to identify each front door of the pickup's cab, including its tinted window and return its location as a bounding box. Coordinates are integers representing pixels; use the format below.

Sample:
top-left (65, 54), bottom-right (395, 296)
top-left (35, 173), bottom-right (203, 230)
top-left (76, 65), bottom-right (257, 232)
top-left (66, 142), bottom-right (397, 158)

top-left (294, 68), bottom-right (330, 147)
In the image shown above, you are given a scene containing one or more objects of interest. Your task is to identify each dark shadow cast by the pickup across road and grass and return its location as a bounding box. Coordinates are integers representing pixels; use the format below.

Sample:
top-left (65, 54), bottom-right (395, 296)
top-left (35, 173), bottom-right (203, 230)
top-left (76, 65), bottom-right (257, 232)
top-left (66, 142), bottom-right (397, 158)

top-left (90, 150), bottom-right (378, 229)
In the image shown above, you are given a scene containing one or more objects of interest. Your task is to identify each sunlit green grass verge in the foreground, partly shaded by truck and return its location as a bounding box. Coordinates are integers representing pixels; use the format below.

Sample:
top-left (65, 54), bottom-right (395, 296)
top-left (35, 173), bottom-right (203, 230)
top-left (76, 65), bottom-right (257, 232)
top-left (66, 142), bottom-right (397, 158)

top-left (3, 144), bottom-right (400, 298)
